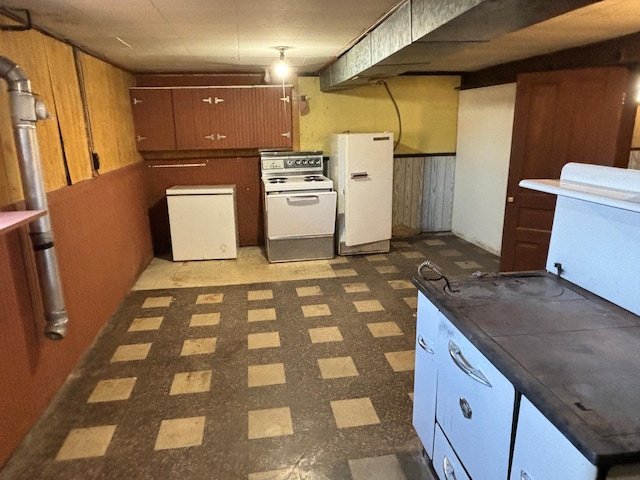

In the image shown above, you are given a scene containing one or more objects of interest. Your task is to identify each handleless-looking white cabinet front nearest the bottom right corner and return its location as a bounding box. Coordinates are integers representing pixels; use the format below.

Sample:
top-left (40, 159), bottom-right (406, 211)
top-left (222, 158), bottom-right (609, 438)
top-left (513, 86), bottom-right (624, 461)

top-left (510, 397), bottom-right (600, 480)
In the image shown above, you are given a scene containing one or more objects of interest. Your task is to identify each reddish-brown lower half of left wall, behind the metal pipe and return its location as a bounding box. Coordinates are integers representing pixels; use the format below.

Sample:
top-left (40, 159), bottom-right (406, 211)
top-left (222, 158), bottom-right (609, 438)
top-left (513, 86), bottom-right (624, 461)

top-left (0, 163), bottom-right (153, 468)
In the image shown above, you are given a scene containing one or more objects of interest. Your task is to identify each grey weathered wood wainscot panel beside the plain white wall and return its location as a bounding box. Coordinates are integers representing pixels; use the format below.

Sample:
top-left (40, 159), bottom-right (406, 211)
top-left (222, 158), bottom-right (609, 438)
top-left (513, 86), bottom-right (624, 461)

top-left (421, 156), bottom-right (455, 232)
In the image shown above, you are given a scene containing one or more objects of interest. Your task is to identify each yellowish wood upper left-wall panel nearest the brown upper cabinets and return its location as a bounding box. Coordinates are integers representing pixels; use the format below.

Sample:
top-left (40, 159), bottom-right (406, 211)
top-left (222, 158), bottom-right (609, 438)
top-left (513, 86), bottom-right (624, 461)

top-left (80, 53), bottom-right (142, 173)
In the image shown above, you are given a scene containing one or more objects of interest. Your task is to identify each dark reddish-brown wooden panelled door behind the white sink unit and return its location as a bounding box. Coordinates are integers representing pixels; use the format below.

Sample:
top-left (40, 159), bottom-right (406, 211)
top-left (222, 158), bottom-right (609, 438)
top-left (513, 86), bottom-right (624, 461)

top-left (500, 67), bottom-right (635, 271)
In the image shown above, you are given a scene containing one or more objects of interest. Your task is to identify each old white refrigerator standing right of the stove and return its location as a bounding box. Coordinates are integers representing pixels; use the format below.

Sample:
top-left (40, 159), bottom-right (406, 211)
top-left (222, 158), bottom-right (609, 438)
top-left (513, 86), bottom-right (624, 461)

top-left (329, 132), bottom-right (393, 255)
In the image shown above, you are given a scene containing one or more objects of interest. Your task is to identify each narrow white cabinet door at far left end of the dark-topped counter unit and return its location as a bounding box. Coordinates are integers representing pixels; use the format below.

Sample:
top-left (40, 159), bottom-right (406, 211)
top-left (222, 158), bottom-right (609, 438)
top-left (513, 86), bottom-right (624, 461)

top-left (413, 293), bottom-right (442, 459)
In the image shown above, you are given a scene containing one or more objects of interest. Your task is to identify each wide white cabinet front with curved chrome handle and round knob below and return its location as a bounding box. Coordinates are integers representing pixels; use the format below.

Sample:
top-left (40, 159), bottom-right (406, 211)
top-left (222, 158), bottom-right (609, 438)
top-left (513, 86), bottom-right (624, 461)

top-left (436, 316), bottom-right (515, 480)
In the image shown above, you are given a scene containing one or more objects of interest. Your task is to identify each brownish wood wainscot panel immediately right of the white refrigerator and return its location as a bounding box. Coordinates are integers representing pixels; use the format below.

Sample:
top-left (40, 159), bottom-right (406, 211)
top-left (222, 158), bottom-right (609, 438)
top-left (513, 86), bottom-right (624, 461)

top-left (392, 157), bottom-right (424, 237)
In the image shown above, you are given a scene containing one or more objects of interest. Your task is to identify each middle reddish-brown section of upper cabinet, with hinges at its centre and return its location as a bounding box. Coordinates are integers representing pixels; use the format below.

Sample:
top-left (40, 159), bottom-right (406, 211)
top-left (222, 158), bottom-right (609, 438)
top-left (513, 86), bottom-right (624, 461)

top-left (173, 88), bottom-right (253, 150)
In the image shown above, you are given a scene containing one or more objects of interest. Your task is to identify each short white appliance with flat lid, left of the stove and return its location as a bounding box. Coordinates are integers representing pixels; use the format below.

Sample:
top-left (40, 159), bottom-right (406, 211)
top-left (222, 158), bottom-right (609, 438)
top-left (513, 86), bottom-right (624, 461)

top-left (166, 185), bottom-right (238, 261)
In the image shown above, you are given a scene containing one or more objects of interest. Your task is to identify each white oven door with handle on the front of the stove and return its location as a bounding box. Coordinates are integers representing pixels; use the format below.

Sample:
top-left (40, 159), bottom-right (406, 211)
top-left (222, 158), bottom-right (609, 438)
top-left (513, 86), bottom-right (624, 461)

top-left (265, 191), bottom-right (337, 240)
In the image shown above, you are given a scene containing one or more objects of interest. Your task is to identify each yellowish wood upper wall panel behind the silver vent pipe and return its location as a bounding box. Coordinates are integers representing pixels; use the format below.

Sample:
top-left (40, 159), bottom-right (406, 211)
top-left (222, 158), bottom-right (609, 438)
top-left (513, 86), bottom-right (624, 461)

top-left (0, 22), bottom-right (67, 197)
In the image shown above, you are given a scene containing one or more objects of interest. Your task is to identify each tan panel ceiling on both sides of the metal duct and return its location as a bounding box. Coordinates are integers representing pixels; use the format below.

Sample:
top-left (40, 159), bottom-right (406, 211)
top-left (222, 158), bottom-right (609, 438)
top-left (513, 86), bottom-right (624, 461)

top-left (0, 0), bottom-right (640, 74)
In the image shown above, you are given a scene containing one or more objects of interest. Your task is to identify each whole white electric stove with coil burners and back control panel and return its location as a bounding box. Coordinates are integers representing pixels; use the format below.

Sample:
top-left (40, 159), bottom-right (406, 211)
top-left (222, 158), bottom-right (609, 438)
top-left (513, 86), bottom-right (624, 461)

top-left (260, 152), bottom-right (336, 263)
